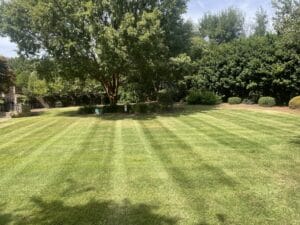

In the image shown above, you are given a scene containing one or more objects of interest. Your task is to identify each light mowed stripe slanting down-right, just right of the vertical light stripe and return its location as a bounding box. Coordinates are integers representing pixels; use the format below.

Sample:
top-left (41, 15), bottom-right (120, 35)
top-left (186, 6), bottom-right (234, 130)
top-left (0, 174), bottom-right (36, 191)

top-left (133, 121), bottom-right (198, 224)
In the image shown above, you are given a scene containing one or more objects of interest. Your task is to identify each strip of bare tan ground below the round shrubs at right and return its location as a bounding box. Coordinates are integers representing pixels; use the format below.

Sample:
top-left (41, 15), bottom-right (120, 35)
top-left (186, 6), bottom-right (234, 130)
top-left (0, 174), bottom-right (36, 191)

top-left (219, 103), bottom-right (300, 115)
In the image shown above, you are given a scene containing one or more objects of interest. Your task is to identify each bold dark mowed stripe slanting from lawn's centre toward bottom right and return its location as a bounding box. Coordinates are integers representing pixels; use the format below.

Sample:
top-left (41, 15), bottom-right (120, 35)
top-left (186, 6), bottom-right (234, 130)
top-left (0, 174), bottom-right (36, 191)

top-left (141, 120), bottom-right (208, 223)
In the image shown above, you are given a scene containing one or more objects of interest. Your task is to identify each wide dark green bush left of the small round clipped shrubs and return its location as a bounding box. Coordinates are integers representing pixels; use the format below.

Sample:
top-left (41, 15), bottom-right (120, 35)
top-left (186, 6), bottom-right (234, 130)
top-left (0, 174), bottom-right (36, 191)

top-left (186, 90), bottom-right (221, 105)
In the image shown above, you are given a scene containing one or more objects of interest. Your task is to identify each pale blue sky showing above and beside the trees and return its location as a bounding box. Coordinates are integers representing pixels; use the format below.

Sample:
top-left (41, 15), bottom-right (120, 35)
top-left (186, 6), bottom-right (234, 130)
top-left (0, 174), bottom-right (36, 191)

top-left (0, 0), bottom-right (273, 57)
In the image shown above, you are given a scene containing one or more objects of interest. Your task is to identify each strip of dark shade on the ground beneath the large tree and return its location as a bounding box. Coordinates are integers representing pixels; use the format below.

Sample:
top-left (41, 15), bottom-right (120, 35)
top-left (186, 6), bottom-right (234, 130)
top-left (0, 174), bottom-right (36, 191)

top-left (56, 105), bottom-right (218, 120)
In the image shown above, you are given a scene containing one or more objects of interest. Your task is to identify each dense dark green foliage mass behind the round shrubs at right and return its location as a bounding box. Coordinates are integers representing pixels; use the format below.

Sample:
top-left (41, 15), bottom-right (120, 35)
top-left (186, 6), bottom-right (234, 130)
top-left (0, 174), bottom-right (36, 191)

top-left (193, 35), bottom-right (300, 103)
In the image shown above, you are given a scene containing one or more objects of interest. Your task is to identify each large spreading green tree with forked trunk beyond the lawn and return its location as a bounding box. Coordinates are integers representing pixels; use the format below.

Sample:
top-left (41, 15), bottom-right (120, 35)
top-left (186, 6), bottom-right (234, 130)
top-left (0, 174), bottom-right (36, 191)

top-left (0, 0), bottom-right (186, 104)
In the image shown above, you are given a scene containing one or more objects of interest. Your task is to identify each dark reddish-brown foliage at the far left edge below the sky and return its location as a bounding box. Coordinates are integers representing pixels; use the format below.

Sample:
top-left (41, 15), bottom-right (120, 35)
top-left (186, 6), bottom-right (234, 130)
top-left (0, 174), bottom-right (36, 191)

top-left (0, 56), bottom-right (14, 93)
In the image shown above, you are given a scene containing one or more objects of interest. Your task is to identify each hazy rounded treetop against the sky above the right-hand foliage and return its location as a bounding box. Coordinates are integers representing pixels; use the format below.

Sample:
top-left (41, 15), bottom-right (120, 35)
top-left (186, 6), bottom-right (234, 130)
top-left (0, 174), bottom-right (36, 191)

top-left (199, 8), bottom-right (245, 44)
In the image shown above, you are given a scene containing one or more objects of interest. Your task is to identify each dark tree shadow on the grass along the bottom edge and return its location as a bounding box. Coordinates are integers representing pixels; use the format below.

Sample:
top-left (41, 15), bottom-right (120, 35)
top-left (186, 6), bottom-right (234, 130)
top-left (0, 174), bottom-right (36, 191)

top-left (14, 197), bottom-right (178, 225)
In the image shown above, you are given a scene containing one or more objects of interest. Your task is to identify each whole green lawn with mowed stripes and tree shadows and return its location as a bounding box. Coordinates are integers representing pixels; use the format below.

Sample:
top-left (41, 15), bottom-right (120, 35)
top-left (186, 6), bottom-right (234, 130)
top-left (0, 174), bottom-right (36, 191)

top-left (0, 107), bottom-right (300, 225)
